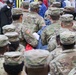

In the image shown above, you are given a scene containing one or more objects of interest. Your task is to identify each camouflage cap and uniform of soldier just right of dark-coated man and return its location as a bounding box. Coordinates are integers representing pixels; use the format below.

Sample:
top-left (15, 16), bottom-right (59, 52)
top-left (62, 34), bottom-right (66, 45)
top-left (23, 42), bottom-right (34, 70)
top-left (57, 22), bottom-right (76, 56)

top-left (12, 8), bottom-right (25, 44)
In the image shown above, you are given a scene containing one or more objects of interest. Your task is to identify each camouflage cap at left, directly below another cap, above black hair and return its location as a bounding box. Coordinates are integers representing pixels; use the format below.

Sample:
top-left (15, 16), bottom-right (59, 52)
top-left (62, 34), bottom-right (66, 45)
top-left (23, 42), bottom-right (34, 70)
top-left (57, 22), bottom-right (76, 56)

top-left (4, 32), bottom-right (19, 42)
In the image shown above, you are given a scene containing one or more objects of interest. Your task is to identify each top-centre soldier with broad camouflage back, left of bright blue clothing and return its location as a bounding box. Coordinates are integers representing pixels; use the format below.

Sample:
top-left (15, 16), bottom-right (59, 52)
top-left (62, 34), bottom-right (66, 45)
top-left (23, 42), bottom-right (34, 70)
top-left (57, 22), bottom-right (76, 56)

top-left (23, 2), bottom-right (45, 32)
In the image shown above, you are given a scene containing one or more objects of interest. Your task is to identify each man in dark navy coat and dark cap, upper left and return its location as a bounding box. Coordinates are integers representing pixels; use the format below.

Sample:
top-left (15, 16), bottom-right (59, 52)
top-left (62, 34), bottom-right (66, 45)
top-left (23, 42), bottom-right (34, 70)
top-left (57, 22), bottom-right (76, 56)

top-left (0, 1), bottom-right (13, 33)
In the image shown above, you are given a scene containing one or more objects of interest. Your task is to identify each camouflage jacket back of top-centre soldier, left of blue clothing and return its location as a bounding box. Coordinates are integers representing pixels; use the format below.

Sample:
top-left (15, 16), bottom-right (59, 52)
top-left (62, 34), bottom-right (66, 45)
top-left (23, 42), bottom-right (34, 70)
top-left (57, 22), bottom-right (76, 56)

top-left (23, 12), bottom-right (45, 32)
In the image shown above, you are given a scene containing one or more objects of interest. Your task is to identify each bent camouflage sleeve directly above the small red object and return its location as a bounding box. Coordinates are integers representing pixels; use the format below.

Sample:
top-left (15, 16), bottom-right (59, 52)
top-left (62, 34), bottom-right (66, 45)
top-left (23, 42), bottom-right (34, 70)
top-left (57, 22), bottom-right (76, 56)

top-left (22, 28), bottom-right (38, 47)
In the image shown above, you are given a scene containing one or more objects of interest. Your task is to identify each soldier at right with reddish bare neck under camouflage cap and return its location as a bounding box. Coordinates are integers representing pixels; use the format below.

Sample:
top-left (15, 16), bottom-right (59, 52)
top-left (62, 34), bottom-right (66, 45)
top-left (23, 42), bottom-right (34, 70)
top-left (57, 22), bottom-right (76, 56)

top-left (48, 14), bottom-right (74, 51)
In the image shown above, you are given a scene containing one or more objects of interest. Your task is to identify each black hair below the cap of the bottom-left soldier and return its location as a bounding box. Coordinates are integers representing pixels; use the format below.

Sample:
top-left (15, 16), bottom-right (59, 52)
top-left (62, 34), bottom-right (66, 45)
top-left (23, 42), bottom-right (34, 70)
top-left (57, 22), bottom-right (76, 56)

top-left (3, 62), bottom-right (24, 75)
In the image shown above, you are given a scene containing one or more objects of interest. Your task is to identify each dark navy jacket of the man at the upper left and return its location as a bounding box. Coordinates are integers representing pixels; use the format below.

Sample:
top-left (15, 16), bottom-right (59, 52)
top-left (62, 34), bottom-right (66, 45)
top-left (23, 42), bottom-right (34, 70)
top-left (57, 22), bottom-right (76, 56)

top-left (0, 5), bottom-right (12, 33)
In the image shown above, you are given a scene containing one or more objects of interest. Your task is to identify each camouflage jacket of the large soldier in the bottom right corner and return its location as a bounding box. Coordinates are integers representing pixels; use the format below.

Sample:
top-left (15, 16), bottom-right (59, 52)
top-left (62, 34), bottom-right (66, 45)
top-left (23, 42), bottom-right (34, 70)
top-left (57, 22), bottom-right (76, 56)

top-left (50, 49), bottom-right (76, 75)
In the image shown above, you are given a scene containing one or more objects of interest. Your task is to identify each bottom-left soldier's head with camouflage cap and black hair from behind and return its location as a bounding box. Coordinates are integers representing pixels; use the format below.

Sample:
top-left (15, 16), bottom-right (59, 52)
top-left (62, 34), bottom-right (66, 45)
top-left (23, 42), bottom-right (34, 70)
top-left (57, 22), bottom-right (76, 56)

top-left (3, 52), bottom-right (24, 75)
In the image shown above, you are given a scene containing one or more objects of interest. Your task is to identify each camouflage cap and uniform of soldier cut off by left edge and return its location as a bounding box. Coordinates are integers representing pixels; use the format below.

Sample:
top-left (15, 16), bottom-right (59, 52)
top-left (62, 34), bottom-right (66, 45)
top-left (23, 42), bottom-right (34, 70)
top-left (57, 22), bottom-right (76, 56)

top-left (0, 35), bottom-right (10, 75)
